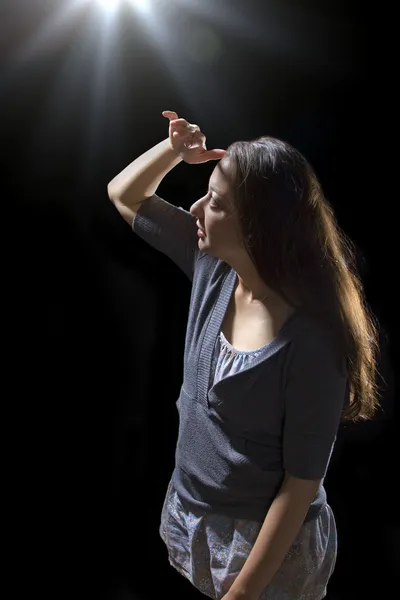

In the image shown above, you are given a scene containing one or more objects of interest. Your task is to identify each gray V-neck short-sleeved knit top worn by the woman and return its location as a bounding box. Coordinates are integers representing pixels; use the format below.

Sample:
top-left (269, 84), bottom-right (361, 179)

top-left (133, 195), bottom-right (348, 521)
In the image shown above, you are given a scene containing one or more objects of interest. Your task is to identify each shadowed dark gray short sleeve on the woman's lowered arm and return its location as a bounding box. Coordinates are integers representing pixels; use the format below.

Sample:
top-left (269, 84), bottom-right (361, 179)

top-left (283, 332), bottom-right (348, 479)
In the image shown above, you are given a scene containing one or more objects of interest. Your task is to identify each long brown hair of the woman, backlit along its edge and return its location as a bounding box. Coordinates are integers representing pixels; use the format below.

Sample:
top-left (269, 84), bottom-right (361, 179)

top-left (226, 137), bottom-right (379, 421)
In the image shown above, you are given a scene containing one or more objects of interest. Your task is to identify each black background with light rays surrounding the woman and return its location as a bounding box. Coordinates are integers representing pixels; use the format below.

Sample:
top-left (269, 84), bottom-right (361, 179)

top-left (0, 0), bottom-right (399, 600)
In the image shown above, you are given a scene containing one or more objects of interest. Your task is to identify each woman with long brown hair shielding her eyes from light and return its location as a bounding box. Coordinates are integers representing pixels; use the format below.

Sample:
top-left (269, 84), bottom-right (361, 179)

top-left (108, 111), bottom-right (378, 600)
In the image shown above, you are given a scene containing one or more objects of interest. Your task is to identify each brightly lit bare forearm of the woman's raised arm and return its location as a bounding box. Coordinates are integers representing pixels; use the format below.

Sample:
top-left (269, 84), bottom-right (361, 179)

top-left (107, 138), bottom-right (182, 206)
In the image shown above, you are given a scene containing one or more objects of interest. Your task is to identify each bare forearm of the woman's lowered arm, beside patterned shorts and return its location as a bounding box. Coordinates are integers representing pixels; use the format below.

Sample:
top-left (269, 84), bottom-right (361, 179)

top-left (230, 476), bottom-right (319, 600)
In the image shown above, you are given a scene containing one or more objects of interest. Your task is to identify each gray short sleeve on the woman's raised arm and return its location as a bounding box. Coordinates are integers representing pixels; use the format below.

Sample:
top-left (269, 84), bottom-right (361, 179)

top-left (132, 194), bottom-right (200, 281)
